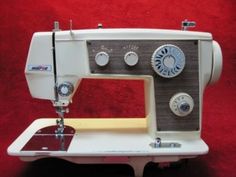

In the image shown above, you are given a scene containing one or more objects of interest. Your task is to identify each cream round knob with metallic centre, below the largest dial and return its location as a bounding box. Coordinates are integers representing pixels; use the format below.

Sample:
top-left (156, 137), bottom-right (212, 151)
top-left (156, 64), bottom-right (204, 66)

top-left (169, 93), bottom-right (194, 117)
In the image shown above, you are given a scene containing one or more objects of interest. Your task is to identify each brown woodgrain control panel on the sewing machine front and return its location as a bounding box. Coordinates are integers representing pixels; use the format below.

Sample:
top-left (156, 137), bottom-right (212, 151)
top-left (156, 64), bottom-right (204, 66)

top-left (87, 40), bottom-right (200, 131)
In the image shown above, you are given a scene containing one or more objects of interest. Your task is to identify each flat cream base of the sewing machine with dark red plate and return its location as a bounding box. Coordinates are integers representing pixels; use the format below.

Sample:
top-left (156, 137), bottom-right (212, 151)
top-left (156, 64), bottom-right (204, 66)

top-left (8, 119), bottom-right (208, 176)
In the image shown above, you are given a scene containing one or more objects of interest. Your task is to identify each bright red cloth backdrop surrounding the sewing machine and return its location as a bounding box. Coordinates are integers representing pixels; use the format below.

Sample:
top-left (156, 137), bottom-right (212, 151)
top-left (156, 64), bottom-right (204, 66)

top-left (0, 0), bottom-right (236, 177)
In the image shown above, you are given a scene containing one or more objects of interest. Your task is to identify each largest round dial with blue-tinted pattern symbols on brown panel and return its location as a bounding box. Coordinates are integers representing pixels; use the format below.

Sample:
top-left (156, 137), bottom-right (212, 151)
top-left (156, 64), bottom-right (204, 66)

top-left (152, 44), bottom-right (185, 78)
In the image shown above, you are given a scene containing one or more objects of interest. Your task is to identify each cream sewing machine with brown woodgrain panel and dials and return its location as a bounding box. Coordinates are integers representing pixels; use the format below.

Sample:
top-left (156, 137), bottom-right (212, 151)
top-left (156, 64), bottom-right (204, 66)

top-left (8, 21), bottom-right (222, 176)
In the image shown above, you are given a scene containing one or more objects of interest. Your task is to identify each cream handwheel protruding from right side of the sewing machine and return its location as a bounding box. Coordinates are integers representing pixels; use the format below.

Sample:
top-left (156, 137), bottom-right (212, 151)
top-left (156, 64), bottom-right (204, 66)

top-left (210, 41), bottom-right (222, 84)
